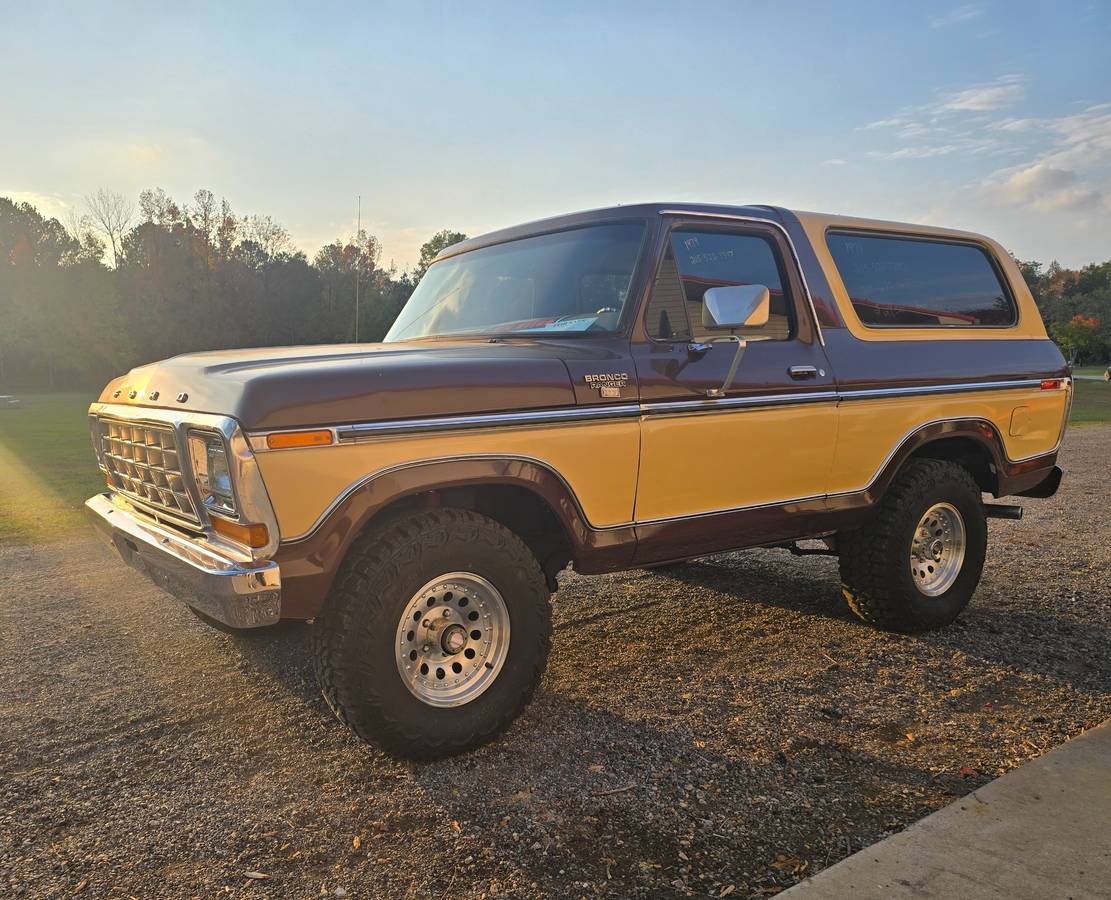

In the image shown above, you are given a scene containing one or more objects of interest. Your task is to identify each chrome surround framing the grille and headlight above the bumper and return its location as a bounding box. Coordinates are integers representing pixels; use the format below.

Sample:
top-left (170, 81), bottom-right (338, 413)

top-left (89, 403), bottom-right (280, 560)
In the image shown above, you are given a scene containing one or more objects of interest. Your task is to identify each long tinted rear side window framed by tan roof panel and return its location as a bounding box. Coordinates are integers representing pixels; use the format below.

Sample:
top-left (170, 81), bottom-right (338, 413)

top-left (827, 232), bottom-right (1018, 328)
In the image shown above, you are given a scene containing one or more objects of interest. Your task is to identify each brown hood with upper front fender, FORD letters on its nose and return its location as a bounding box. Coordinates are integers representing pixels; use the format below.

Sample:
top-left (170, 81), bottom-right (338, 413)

top-left (100, 340), bottom-right (612, 431)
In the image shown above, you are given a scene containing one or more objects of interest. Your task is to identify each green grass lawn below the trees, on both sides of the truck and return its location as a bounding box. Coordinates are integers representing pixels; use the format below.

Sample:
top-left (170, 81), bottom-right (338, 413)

top-left (0, 382), bottom-right (1111, 542)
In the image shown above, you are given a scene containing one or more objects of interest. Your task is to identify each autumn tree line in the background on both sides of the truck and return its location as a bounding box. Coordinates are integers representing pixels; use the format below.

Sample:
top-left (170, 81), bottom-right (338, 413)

top-left (0, 189), bottom-right (1111, 390)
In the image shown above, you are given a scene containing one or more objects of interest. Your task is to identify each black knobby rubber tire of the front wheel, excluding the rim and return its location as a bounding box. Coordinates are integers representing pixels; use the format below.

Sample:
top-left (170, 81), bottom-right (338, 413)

top-left (312, 509), bottom-right (551, 760)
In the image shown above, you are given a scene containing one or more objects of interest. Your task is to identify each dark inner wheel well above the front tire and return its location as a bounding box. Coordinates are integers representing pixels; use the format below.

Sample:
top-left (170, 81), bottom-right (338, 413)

top-left (363, 484), bottom-right (573, 591)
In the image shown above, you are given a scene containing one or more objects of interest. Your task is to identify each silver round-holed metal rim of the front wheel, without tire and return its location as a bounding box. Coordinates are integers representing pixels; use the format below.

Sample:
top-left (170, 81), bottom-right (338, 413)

top-left (393, 572), bottom-right (509, 707)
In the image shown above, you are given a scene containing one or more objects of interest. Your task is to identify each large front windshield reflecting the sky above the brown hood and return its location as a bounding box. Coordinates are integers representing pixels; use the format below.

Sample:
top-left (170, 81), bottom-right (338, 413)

top-left (386, 222), bottom-right (645, 341)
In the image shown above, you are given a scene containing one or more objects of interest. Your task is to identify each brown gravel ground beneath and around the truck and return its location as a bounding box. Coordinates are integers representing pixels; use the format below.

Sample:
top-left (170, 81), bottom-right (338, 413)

top-left (0, 427), bottom-right (1111, 898)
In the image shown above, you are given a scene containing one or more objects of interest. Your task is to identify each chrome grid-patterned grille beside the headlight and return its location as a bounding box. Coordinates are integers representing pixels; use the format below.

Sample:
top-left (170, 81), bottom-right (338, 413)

top-left (97, 417), bottom-right (199, 523)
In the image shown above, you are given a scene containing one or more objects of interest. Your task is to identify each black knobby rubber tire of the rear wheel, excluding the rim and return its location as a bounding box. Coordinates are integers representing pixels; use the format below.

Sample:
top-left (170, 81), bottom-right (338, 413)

top-left (837, 459), bottom-right (988, 632)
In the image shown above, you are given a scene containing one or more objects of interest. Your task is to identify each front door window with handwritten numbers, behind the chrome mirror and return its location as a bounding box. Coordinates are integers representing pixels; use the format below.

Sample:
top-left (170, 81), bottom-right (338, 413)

top-left (647, 229), bottom-right (792, 340)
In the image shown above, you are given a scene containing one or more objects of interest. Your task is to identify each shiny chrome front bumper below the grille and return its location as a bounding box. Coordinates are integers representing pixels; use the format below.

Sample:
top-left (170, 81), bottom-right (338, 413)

top-left (84, 493), bottom-right (281, 628)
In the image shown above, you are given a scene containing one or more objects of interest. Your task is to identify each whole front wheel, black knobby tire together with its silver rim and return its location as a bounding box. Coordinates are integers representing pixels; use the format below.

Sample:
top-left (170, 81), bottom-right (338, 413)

top-left (313, 509), bottom-right (551, 759)
